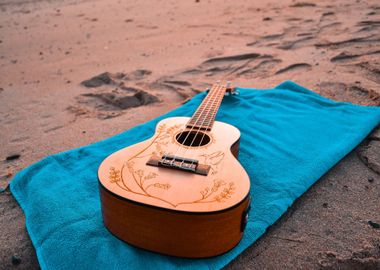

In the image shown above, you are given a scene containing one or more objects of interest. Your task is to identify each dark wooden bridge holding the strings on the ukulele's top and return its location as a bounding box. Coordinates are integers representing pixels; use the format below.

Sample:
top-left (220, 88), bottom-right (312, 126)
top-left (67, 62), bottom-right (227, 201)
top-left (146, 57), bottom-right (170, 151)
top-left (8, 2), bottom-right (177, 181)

top-left (146, 155), bottom-right (210, 175)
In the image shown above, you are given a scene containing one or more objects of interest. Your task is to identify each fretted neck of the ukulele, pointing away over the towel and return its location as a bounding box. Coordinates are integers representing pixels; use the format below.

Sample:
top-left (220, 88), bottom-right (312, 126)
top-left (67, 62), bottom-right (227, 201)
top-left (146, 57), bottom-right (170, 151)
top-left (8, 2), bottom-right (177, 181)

top-left (186, 84), bottom-right (232, 131)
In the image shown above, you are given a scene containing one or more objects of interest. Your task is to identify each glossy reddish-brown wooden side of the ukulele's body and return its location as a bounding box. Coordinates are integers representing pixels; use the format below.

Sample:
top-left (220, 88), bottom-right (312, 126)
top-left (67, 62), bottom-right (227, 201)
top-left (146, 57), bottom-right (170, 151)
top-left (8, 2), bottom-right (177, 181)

top-left (100, 141), bottom-right (250, 258)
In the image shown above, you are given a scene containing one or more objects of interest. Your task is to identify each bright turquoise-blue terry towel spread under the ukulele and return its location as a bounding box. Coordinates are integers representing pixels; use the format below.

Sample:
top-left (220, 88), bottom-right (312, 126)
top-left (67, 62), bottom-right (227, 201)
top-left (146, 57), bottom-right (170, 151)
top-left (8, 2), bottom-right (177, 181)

top-left (11, 82), bottom-right (380, 270)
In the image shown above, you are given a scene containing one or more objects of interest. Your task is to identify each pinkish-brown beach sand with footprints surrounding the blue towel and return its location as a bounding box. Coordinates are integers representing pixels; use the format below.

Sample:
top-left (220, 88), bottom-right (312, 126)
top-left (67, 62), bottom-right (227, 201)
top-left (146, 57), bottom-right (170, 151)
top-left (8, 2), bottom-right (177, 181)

top-left (0, 0), bottom-right (380, 269)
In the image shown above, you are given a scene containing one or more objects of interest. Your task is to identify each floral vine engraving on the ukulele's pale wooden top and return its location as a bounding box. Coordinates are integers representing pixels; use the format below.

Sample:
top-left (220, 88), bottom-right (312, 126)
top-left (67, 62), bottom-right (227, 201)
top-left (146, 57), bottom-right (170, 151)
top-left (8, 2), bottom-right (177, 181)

top-left (109, 124), bottom-right (235, 207)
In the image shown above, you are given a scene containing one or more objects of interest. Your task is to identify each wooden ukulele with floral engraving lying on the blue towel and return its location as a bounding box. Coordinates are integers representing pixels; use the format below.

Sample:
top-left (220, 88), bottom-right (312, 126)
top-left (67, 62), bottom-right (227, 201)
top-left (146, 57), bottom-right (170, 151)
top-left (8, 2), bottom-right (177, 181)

top-left (98, 83), bottom-right (250, 258)
